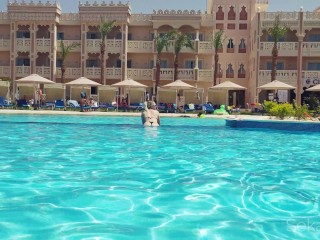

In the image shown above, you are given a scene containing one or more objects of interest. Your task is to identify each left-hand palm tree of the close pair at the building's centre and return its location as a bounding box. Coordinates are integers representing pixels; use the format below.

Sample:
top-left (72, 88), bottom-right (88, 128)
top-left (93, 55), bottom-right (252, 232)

top-left (154, 31), bottom-right (175, 96)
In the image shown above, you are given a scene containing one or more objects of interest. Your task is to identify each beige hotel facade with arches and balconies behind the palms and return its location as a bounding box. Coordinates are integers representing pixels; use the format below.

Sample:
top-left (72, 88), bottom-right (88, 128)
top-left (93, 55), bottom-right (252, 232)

top-left (0, 0), bottom-right (320, 105)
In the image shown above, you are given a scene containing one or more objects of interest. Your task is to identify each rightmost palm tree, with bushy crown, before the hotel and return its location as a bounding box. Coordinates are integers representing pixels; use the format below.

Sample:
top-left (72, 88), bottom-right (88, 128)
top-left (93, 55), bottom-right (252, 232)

top-left (267, 15), bottom-right (289, 82)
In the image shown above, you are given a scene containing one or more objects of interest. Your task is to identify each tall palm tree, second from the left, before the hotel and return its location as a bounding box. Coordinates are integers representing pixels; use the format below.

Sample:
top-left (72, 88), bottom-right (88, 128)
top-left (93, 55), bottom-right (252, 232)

top-left (99, 21), bottom-right (116, 84)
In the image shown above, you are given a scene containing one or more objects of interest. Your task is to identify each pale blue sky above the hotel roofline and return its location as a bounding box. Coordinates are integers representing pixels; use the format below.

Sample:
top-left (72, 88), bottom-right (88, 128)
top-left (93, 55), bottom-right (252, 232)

top-left (0, 0), bottom-right (320, 13)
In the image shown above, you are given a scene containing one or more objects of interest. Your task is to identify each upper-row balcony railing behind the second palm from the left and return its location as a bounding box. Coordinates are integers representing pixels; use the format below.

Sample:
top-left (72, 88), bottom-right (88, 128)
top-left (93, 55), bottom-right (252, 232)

top-left (87, 39), bottom-right (122, 54)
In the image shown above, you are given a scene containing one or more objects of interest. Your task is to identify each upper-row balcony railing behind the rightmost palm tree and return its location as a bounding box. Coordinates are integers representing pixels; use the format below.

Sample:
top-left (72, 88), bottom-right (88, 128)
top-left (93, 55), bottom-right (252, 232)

top-left (260, 42), bottom-right (298, 57)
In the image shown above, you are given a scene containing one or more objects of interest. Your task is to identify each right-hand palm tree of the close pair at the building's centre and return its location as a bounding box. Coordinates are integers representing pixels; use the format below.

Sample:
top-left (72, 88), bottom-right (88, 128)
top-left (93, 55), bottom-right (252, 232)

top-left (174, 32), bottom-right (194, 81)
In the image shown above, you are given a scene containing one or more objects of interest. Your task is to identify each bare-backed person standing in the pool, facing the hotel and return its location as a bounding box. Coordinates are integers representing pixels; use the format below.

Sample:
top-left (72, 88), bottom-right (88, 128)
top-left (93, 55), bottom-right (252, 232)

top-left (141, 101), bottom-right (160, 127)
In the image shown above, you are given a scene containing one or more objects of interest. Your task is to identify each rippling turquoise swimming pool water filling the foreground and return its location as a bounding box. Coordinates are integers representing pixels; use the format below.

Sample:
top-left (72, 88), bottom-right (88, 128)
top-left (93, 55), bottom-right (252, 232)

top-left (0, 115), bottom-right (320, 240)
